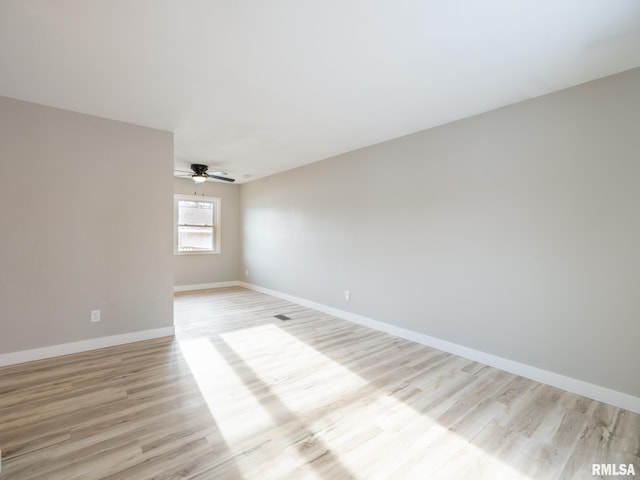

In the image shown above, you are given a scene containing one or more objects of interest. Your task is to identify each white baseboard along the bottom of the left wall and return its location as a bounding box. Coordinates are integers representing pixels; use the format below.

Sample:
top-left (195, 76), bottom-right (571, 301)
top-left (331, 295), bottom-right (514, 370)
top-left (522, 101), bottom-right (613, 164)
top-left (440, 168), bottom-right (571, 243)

top-left (0, 327), bottom-right (175, 367)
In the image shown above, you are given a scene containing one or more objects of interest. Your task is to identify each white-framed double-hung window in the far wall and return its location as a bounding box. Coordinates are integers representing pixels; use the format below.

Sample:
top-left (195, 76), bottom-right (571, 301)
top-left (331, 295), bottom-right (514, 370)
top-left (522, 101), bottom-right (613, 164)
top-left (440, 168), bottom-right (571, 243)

top-left (173, 195), bottom-right (220, 255)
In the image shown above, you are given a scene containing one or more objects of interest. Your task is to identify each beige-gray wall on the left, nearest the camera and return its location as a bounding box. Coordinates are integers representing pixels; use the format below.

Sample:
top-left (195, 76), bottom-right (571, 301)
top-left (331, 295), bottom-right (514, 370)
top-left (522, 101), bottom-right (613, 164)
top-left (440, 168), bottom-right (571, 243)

top-left (0, 97), bottom-right (173, 353)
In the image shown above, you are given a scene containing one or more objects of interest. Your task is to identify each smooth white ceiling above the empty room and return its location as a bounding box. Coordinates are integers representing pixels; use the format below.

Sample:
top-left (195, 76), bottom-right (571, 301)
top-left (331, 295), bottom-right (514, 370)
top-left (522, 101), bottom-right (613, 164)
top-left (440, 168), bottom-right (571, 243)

top-left (0, 0), bottom-right (640, 182)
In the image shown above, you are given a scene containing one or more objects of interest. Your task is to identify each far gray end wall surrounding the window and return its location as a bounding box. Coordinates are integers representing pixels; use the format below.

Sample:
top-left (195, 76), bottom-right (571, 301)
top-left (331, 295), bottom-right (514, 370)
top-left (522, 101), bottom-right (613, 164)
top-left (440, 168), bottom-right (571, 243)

top-left (173, 178), bottom-right (241, 286)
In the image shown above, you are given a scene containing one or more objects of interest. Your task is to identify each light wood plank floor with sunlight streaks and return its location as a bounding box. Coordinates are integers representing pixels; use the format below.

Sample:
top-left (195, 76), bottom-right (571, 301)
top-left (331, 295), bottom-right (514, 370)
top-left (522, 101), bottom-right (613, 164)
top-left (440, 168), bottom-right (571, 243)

top-left (0, 288), bottom-right (640, 480)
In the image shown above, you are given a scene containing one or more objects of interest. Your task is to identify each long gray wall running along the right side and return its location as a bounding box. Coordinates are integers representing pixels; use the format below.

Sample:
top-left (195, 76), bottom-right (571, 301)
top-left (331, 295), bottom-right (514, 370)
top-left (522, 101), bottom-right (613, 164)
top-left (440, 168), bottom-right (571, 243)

top-left (241, 69), bottom-right (640, 396)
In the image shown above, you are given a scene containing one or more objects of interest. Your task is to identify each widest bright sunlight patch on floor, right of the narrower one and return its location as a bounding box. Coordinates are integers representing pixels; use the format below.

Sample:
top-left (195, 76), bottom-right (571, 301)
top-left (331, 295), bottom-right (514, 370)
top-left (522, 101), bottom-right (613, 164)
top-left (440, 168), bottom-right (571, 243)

top-left (221, 324), bottom-right (528, 479)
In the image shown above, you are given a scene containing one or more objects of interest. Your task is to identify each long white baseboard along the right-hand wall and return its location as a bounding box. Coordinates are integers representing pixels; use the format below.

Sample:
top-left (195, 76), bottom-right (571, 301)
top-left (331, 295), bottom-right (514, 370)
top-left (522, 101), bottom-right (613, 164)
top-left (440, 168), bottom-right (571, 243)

top-left (239, 282), bottom-right (640, 414)
